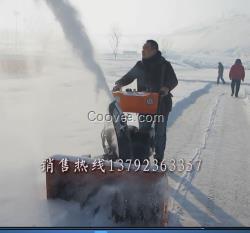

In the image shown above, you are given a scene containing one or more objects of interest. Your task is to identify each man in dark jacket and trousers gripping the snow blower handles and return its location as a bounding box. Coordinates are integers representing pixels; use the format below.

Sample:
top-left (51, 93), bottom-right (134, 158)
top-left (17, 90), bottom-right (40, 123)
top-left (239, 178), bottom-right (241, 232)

top-left (113, 40), bottom-right (178, 164)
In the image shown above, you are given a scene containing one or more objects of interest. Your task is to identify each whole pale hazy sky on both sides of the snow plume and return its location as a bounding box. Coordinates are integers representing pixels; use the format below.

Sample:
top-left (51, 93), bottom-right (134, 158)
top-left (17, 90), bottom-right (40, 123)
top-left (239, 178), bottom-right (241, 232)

top-left (0, 0), bottom-right (250, 51)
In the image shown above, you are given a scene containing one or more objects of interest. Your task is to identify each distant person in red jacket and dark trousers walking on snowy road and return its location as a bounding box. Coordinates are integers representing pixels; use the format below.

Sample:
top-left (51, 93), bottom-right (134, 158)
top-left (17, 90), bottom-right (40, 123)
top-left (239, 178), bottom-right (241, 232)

top-left (229, 59), bottom-right (245, 97)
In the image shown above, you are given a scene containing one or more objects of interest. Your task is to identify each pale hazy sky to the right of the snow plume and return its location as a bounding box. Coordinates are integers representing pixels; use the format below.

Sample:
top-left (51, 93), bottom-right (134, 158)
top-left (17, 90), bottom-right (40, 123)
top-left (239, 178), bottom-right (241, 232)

top-left (72, 0), bottom-right (250, 34)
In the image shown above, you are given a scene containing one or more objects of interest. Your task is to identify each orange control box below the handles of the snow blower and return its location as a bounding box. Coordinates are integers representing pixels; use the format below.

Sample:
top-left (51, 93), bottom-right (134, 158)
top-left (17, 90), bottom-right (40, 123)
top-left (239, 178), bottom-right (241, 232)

top-left (113, 91), bottom-right (159, 114)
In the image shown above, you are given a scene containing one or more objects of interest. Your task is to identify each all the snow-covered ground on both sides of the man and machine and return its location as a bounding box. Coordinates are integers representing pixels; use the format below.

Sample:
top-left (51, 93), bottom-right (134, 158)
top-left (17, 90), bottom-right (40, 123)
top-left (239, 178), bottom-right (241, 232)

top-left (0, 52), bottom-right (250, 226)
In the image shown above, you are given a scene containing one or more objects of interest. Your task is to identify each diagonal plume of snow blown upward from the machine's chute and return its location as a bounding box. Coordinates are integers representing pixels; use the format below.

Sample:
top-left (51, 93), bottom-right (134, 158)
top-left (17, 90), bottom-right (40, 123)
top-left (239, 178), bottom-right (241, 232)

top-left (46, 0), bottom-right (111, 98)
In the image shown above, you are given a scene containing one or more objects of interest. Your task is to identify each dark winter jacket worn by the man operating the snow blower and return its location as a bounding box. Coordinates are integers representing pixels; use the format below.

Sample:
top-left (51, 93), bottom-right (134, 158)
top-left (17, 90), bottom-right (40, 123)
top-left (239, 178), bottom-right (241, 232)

top-left (116, 51), bottom-right (178, 115)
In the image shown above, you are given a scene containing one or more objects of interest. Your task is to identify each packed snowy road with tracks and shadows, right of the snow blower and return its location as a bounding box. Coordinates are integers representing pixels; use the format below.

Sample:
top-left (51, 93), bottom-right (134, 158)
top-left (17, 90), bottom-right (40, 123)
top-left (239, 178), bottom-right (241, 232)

top-left (166, 81), bottom-right (250, 226)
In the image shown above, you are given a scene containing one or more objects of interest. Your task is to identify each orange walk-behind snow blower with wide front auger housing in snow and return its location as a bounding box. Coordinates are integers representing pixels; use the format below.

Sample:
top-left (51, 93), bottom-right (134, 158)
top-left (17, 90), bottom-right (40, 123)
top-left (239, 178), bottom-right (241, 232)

top-left (46, 89), bottom-right (168, 227)
